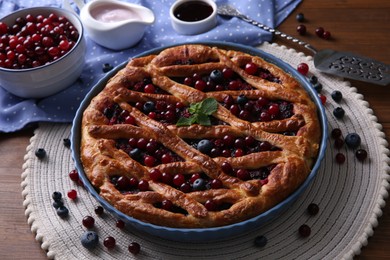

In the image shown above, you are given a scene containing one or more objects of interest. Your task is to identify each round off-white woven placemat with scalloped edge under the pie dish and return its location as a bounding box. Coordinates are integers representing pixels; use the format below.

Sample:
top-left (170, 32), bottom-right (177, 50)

top-left (21, 44), bottom-right (390, 259)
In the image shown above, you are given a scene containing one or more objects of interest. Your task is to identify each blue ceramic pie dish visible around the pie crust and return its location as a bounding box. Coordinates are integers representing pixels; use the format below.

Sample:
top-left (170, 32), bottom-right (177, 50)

top-left (71, 42), bottom-right (328, 242)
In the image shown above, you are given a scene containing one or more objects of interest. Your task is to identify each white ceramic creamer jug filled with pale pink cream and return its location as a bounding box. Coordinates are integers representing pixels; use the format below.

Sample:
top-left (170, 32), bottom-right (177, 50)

top-left (80, 0), bottom-right (155, 50)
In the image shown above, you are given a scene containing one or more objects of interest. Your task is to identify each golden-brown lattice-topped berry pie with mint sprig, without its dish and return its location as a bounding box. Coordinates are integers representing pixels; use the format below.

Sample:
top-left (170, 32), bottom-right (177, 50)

top-left (80, 44), bottom-right (321, 228)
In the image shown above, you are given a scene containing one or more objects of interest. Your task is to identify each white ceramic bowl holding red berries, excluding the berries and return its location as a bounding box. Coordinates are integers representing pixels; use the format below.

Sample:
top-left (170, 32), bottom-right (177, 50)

top-left (0, 7), bottom-right (86, 98)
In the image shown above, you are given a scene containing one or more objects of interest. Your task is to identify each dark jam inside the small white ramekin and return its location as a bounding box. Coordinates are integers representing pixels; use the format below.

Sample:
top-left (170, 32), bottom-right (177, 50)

top-left (173, 1), bottom-right (213, 22)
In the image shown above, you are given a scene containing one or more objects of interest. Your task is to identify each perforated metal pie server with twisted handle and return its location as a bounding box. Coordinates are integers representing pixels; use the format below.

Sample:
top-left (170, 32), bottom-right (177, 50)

top-left (217, 5), bottom-right (390, 86)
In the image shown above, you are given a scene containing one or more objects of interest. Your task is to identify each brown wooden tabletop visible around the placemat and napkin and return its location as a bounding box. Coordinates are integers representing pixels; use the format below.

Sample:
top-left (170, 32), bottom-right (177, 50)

top-left (0, 0), bottom-right (390, 259)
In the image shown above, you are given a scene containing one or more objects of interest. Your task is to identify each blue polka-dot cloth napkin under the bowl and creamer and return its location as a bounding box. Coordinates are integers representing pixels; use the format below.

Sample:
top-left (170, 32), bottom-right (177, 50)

top-left (0, 0), bottom-right (301, 132)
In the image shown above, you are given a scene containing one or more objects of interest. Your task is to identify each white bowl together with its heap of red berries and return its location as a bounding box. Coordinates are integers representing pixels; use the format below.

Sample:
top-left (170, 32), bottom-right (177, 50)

top-left (0, 7), bottom-right (86, 98)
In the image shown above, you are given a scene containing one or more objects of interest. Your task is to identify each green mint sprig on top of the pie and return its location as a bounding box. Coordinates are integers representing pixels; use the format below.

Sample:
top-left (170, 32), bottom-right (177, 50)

top-left (176, 98), bottom-right (218, 126)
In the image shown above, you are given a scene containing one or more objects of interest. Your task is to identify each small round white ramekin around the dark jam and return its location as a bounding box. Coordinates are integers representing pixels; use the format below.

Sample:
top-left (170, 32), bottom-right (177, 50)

top-left (169, 0), bottom-right (217, 35)
